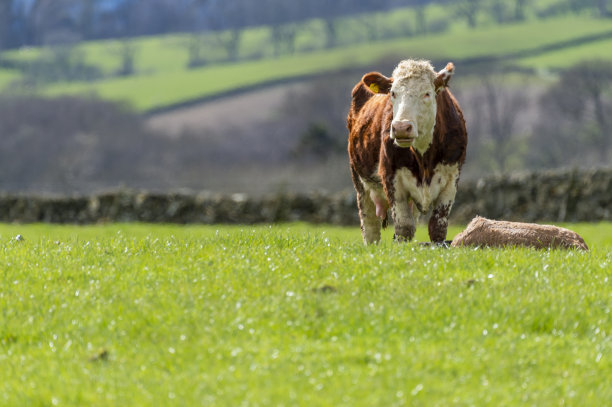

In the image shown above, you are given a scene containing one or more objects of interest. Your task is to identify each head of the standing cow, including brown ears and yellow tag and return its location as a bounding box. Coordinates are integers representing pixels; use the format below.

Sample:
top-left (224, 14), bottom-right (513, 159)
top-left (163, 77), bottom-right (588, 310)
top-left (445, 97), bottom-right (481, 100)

top-left (362, 59), bottom-right (455, 154)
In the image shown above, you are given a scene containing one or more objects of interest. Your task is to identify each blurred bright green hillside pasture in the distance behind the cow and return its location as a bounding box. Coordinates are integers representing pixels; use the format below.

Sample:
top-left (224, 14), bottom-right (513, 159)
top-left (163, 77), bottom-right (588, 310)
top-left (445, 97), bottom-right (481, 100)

top-left (0, 9), bottom-right (612, 112)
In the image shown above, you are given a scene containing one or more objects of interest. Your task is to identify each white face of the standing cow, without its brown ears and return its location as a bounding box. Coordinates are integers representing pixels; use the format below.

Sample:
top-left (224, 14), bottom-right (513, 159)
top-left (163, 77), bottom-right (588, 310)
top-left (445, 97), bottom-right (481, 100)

top-left (389, 74), bottom-right (436, 154)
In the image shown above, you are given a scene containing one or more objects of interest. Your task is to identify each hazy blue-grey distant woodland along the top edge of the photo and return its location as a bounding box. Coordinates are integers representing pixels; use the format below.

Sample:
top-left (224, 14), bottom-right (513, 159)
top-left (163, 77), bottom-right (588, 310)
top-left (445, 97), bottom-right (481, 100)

top-left (0, 0), bottom-right (611, 50)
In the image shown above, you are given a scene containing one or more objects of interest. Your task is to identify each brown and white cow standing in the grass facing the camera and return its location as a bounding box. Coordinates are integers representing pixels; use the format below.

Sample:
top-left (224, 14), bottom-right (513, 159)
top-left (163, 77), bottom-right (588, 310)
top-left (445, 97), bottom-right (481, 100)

top-left (347, 60), bottom-right (467, 244)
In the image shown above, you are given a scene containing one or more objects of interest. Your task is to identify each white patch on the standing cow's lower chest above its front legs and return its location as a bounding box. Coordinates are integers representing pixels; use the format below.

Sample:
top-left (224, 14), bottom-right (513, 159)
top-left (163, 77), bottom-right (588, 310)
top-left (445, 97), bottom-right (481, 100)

top-left (394, 164), bottom-right (459, 211)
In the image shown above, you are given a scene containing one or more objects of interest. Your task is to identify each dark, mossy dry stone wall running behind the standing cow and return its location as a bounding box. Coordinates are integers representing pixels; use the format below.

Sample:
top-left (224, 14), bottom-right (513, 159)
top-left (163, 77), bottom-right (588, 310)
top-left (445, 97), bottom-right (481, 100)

top-left (0, 169), bottom-right (612, 225)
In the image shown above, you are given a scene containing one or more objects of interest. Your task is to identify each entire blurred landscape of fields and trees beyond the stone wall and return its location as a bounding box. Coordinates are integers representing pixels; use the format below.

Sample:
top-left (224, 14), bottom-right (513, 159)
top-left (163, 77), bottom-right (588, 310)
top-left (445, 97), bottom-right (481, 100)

top-left (0, 0), bottom-right (612, 194)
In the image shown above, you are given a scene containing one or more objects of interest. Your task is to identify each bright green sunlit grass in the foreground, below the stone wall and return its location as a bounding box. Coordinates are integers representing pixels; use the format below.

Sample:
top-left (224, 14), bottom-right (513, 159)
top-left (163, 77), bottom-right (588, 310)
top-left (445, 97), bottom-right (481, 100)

top-left (0, 223), bottom-right (612, 406)
